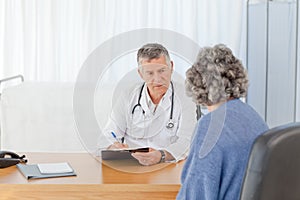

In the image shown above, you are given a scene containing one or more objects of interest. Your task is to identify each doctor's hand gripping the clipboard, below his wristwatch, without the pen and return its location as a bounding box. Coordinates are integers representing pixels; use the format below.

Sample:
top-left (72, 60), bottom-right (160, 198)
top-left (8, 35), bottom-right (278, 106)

top-left (131, 148), bottom-right (161, 165)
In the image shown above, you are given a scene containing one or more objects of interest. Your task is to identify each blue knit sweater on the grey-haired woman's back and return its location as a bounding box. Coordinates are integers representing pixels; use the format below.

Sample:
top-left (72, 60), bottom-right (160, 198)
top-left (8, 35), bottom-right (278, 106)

top-left (177, 99), bottom-right (268, 200)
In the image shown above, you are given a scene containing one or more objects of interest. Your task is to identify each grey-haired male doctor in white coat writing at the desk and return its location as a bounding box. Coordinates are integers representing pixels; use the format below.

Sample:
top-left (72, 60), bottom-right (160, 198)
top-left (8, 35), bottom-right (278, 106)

top-left (98, 43), bottom-right (196, 165)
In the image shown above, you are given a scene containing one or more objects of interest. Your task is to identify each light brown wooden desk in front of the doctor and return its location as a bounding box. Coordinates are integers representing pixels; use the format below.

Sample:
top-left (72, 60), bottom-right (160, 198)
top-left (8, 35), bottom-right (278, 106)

top-left (0, 153), bottom-right (184, 199)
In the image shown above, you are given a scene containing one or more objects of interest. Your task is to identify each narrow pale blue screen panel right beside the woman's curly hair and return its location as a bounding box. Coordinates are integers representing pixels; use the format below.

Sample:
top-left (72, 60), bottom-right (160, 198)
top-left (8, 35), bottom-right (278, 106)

top-left (247, 1), bottom-right (267, 118)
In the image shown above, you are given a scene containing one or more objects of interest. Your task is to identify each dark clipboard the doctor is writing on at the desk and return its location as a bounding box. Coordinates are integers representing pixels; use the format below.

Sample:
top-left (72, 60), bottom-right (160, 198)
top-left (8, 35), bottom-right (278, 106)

top-left (101, 147), bottom-right (149, 160)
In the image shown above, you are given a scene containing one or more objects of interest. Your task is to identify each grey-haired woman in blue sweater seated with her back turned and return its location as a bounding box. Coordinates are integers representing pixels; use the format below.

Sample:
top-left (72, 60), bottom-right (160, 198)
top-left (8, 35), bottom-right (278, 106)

top-left (177, 44), bottom-right (268, 200)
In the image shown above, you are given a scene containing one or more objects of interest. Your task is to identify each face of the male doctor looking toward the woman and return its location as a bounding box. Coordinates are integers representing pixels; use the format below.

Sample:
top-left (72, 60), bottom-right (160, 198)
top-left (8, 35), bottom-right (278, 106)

top-left (139, 56), bottom-right (173, 95)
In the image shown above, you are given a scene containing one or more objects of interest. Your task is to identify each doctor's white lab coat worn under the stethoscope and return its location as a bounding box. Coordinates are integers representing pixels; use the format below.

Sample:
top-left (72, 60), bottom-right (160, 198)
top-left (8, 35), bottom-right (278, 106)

top-left (98, 82), bottom-right (196, 161)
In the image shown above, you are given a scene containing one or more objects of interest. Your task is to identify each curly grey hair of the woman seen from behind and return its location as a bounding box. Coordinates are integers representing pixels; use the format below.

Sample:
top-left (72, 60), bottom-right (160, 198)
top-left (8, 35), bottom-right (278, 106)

top-left (185, 44), bottom-right (248, 106)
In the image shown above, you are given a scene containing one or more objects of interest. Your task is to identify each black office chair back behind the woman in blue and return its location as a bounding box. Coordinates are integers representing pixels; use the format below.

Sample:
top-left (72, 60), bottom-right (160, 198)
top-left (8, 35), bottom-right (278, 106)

top-left (240, 123), bottom-right (300, 200)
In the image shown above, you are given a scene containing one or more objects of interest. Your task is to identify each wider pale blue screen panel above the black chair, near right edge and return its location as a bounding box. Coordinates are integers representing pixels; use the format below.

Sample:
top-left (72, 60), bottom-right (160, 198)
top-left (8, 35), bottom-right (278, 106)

top-left (267, 1), bottom-right (297, 127)
